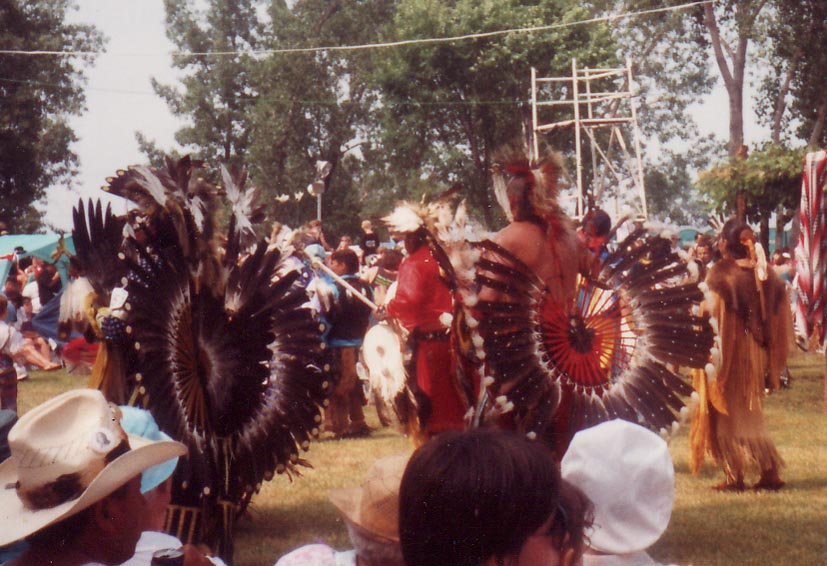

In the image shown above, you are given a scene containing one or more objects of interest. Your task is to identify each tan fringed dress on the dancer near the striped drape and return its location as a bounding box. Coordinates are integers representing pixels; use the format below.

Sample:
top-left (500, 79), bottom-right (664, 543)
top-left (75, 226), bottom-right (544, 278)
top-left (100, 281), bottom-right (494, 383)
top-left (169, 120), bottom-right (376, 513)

top-left (690, 259), bottom-right (792, 485)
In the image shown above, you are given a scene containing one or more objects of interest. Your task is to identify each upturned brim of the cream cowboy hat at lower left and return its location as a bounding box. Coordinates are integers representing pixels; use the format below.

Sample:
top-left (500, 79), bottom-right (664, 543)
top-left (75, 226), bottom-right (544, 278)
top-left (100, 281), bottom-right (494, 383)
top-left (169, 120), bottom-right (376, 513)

top-left (0, 434), bottom-right (187, 546)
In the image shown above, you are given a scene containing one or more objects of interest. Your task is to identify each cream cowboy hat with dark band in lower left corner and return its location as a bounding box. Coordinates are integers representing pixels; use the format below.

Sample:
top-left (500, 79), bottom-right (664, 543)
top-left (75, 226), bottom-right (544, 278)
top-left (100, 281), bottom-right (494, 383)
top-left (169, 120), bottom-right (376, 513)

top-left (0, 389), bottom-right (187, 546)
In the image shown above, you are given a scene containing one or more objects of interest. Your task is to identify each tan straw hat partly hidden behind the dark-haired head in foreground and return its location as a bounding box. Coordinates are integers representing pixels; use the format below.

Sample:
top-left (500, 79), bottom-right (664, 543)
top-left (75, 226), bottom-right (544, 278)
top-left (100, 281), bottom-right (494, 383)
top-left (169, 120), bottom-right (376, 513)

top-left (330, 454), bottom-right (410, 542)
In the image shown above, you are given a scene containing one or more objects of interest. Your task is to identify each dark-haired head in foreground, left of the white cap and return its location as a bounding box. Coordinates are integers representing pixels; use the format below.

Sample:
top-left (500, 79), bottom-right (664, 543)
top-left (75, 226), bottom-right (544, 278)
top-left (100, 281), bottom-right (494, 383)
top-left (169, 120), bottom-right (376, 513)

top-left (399, 429), bottom-right (589, 566)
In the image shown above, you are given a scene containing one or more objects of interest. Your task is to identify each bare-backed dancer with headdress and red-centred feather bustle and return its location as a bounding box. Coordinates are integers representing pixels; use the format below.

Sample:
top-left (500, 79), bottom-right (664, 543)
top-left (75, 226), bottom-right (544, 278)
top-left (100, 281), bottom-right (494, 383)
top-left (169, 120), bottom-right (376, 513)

top-left (462, 150), bottom-right (713, 458)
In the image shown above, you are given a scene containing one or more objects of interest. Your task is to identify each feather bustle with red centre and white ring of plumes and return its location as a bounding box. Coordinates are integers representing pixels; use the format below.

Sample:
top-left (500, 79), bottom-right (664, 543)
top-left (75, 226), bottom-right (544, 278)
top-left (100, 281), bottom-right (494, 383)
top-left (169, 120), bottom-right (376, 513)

top-left (464, 231), bottom-right (714, 449)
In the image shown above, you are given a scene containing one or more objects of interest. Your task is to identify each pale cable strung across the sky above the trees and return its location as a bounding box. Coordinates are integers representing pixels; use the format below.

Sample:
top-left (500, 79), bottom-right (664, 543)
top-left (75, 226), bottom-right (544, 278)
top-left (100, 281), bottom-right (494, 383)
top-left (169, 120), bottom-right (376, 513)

top-left (0, 0), bottom-right (717, 57)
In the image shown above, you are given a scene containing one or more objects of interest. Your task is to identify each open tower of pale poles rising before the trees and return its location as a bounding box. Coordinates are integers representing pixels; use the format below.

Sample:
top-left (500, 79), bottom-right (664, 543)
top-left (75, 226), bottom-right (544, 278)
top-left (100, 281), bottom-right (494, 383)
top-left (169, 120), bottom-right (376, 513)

top-left (531, 58), bottom-right (648, 217)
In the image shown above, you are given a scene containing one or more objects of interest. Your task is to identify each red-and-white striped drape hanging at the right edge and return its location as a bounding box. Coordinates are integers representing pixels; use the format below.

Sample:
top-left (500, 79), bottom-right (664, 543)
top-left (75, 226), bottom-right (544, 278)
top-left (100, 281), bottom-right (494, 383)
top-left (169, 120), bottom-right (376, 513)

top-left (795, 150), bottom-right (827, 343)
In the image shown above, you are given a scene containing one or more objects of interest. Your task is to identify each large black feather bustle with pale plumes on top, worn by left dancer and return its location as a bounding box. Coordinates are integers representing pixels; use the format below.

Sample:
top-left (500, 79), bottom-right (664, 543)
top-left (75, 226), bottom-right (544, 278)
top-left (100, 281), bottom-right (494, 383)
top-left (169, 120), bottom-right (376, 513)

top-left (71, 158), bottom-right (330, 560)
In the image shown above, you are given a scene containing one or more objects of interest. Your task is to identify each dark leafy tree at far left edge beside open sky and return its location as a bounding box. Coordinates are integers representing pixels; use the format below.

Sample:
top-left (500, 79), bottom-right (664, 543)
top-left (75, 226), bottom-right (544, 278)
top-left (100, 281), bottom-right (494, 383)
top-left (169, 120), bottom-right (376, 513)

top-left (0, 0), bottom-right (103, 232)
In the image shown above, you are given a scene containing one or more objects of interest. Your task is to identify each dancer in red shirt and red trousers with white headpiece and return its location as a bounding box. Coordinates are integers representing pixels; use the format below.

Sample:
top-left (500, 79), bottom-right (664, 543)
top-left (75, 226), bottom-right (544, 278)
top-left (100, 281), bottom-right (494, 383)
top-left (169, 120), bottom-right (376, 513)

top-left (386, 209), bottom-right (466, 440)
